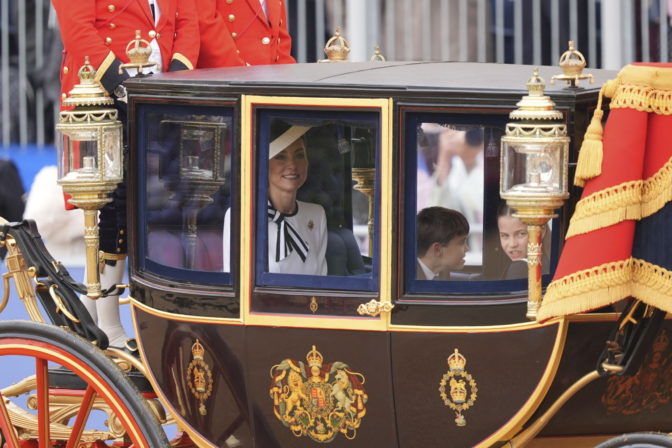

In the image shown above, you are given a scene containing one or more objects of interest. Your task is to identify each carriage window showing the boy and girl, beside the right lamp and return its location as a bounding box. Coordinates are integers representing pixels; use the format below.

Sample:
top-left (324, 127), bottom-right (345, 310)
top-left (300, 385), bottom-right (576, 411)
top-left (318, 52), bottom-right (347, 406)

top-left (403, 114), bottom-right (552, 295)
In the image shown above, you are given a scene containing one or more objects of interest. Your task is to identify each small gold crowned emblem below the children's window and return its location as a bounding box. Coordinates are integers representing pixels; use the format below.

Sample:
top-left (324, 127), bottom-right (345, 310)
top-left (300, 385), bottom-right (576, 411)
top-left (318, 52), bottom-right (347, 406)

top-left (439, 349), bottom-right (478, 426)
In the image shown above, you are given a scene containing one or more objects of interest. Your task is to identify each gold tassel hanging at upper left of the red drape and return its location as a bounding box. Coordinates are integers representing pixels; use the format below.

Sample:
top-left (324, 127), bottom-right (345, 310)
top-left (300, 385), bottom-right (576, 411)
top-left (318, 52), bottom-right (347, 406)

top-left (574, 81), bottom-right (616, 187)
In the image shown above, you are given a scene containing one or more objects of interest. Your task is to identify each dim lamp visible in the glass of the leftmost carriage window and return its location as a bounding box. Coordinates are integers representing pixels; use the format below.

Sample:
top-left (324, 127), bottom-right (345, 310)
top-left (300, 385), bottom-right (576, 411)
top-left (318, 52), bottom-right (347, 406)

top-left (162, 120), bottom-right (227, 269)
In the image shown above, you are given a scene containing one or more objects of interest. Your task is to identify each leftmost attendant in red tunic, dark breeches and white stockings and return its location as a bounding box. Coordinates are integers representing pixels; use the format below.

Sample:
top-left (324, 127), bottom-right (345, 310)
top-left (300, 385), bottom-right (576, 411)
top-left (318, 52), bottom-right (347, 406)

top-left (52, 0), bottom-right (200, 351)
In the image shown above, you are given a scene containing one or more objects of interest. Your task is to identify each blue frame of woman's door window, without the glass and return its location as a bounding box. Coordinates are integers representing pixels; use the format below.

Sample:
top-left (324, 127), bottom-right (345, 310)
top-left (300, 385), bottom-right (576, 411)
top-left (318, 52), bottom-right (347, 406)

top-left (253, 105), bottom-right (383, 293)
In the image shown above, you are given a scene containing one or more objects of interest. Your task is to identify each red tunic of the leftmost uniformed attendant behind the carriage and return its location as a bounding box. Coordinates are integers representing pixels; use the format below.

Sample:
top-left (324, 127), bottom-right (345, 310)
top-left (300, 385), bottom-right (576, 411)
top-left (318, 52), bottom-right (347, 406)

top-left (52, 0), bottom-right (199, 105)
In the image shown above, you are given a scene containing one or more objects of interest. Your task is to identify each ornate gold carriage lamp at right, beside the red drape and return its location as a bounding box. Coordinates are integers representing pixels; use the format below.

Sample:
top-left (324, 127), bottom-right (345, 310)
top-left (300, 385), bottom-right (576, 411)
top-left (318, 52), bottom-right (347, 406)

top-left (500, 69), bottom-right (569, 319)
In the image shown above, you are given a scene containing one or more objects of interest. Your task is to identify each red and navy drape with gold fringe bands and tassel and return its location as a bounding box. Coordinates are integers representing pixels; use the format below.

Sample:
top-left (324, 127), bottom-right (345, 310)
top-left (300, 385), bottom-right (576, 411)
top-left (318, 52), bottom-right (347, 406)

top-left (538, 64), bottom-right (672, 320)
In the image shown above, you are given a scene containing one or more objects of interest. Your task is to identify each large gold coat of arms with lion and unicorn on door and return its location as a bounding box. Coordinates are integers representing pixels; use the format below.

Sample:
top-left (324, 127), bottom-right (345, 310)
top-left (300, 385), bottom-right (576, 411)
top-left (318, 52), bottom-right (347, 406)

top-left (269, 345), bottom-right (368, 443)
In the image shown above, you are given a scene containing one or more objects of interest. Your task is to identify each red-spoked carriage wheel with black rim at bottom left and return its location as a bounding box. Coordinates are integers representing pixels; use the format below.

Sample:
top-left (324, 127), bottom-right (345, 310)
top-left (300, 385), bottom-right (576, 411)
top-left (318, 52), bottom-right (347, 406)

top-left (0, 321), bottom-right (168, 448)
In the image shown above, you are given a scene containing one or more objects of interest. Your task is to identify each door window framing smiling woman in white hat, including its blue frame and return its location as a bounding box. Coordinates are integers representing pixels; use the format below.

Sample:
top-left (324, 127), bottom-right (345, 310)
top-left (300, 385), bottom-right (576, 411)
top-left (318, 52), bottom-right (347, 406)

top-left (256, 110), bottom-right (380, 290)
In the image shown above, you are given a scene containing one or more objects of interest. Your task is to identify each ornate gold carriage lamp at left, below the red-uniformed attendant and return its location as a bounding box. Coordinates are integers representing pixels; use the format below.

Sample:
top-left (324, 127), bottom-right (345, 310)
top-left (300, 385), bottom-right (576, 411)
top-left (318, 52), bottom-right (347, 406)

top-left (56, 57), bottom-right (123, 299)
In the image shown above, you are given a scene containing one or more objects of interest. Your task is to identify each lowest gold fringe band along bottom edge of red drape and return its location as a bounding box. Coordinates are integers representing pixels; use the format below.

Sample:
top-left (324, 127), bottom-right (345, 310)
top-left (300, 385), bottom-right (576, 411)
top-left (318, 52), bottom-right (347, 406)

top-left (537, 258), bottom-right (672, 321)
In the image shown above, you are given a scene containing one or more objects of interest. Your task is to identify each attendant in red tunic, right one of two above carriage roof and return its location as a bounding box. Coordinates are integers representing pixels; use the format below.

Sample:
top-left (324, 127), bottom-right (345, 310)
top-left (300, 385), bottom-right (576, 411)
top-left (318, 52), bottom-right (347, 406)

top-left (196, 0), bottom-right (296, 68)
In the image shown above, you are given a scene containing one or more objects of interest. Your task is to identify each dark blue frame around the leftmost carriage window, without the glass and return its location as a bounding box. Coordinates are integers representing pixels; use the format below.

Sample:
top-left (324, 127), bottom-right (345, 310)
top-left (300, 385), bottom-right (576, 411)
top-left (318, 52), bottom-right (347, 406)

top-left (136, 102), bottom-right (240, 288)
